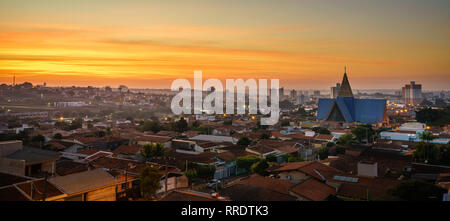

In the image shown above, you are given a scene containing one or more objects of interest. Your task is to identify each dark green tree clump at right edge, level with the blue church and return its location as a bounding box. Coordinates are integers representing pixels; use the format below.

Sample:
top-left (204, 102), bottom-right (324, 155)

top-left (416, 106), bottom-right (450, 126)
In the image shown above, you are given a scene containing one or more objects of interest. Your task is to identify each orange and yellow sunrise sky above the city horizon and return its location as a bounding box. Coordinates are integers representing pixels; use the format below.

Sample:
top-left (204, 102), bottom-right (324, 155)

top-left (0, 0), bottom-right (450, 90)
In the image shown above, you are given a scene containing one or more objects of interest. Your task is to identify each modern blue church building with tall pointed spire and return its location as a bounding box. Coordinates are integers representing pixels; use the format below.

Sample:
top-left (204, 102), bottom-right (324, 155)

top-left (317, 70), bottom-right (389, 126)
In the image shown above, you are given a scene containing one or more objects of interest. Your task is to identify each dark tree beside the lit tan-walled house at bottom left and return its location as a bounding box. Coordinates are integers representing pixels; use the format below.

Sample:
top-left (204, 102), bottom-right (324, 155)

top-left (139, 166), bottom-right (162, 200)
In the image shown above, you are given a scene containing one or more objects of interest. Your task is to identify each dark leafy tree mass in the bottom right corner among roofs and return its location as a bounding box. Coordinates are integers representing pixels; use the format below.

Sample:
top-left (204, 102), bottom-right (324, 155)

top-left (388, 179), bottom-right (447, 201)
